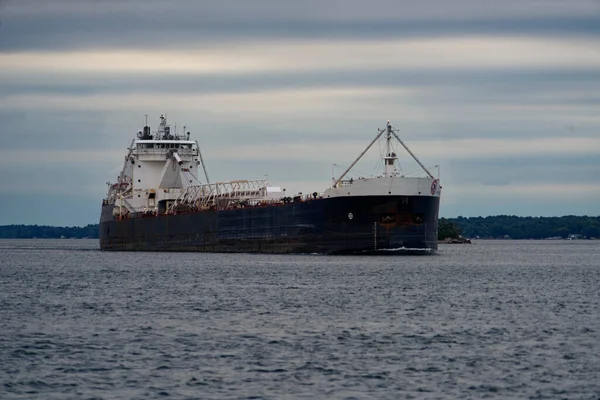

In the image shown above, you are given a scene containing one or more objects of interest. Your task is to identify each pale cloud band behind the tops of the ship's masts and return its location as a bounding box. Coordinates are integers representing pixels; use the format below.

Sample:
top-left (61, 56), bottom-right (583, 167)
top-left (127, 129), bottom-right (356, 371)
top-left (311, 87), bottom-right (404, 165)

top-left (0, 82), bottom-right (600, 150)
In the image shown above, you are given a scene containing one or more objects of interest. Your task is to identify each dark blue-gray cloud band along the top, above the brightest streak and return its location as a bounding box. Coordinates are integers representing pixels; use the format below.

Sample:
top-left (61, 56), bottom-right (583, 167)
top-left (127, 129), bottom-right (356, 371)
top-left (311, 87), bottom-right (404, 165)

top-left (0, 0), bottom-right (600, 51)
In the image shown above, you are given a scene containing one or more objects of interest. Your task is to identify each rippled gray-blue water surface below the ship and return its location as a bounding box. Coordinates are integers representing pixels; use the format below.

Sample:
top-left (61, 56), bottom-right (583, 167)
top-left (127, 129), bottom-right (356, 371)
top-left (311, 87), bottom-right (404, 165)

top-left (0, 240), bottom-right (600, 399)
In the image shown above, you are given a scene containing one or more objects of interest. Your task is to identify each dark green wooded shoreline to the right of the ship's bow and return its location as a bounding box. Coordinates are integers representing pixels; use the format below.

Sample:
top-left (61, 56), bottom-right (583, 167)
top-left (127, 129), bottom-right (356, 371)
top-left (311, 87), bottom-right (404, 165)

top-left (440, 215), bottom-right (600, 239)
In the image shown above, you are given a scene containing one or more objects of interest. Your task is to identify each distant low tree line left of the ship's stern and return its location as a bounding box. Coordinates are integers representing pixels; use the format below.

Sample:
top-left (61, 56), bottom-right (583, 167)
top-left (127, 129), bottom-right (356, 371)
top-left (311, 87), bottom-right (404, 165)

top-left (0, 224), bottom-right (98, 239)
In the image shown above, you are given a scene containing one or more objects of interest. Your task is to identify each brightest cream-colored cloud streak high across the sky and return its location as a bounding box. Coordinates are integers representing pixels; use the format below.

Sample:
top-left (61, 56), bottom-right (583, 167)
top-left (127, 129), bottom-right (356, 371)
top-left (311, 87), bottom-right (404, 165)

top-left (0, 36), bottom-right (600, 74)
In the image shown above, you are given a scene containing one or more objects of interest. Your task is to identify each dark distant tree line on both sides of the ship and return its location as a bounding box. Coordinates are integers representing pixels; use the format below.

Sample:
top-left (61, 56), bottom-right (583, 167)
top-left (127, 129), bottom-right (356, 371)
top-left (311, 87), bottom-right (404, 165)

top-left (0, 215), bottom-right (600, 240)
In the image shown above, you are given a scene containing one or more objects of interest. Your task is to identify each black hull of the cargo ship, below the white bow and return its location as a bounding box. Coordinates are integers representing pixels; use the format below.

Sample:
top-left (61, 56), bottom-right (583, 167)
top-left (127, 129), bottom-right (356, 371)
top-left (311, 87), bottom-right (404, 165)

top-left (100, 196), bottom-right (439, 254)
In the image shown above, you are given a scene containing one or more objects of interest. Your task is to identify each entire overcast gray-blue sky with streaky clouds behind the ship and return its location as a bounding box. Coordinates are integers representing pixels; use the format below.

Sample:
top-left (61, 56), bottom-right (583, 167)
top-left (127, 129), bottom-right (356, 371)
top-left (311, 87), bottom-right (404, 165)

top-left (0, 0), bottom-right (600, 225)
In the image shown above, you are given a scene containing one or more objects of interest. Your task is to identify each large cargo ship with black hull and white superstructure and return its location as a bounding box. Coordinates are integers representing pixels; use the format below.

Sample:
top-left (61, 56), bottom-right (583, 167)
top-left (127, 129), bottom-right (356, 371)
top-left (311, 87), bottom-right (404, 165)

top-left (100, 116), bottom-right (442, 254)
